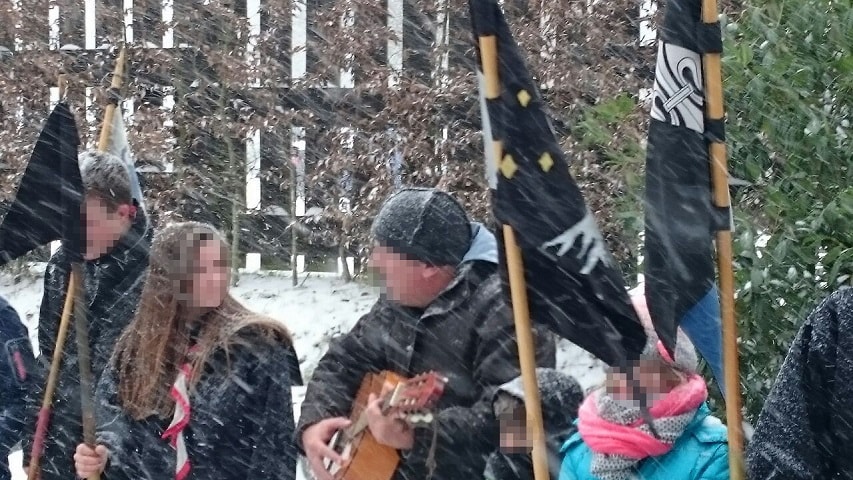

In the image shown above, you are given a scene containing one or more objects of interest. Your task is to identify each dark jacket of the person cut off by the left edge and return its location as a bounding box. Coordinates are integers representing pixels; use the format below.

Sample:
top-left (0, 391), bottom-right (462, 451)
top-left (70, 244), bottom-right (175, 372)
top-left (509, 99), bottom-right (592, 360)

top-left (0, 297), bottom-right (35, 480)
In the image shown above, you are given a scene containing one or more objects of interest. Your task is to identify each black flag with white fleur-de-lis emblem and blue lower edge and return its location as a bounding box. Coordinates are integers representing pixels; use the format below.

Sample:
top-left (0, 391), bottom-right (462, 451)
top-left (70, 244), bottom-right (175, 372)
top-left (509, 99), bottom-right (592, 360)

top-left (644, 0), bottom-right (731, 364)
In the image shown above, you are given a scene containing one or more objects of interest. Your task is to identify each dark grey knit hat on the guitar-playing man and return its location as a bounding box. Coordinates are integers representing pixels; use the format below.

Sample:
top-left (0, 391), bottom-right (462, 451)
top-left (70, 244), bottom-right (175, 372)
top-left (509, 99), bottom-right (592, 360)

top-left (371, 188), bottom-right (471, 266)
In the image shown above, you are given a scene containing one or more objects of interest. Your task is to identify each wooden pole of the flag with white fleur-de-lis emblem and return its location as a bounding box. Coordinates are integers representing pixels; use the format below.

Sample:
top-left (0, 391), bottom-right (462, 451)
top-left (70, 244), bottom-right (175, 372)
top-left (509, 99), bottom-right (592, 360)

top-left (702, 0), bottom-right (746, 480)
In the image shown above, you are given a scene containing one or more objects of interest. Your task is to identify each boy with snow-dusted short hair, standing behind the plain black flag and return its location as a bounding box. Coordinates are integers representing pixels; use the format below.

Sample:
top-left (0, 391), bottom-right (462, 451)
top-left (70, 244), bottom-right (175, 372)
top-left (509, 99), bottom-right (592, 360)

top-left (24, 151), bottom-right (151, 480)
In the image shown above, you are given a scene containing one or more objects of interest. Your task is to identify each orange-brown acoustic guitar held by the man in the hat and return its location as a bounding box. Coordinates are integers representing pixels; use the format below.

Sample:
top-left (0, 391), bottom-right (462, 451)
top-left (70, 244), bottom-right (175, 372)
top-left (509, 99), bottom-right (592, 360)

top-left (326, 371), bottom-right (447, 480)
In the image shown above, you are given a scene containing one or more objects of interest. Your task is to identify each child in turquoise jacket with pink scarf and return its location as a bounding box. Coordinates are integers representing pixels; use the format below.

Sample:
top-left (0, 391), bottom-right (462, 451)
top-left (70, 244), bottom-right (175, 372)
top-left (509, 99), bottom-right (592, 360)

top-left (559, 297), bottom-right (729, 480)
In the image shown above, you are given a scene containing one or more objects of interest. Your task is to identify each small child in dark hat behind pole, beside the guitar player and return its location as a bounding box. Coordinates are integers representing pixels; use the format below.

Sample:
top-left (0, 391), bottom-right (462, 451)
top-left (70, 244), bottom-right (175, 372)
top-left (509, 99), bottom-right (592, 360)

top-left (483, 368), bottom-right (584, 480)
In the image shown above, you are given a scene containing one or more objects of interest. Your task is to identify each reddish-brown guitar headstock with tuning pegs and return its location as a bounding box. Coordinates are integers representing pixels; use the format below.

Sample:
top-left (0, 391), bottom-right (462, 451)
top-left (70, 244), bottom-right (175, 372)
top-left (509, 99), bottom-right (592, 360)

top-left (388, 372), bottom-right (447, 425)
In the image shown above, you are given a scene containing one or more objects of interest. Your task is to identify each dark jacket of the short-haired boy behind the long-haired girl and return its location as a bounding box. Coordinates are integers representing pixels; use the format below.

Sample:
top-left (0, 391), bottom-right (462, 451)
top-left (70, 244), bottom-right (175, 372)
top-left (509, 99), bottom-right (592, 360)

top-left (24, 212), bottom-right (151, 480)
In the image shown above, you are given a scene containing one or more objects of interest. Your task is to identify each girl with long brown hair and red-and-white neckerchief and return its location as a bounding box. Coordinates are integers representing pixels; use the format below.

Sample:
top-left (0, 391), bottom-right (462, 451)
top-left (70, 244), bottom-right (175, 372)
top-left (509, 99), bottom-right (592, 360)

top-left (74, 222), bottom-right (302, 480)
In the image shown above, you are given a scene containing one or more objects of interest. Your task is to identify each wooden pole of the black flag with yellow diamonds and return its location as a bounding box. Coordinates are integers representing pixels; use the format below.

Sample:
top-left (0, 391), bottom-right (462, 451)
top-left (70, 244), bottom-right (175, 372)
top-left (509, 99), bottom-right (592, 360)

top-left (479, 35), bottom-right (549, 480)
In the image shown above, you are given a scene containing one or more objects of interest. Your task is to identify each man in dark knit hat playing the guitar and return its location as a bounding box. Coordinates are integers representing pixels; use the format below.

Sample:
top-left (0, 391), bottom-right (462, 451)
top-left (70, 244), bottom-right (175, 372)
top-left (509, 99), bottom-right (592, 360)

top-left (296, 188), bottom-right (555, 480)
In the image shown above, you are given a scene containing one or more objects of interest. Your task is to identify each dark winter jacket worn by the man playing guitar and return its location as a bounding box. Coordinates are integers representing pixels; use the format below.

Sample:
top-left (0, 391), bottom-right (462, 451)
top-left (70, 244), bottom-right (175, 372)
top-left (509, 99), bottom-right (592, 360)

top-left (296, 226), bottom-right (555, 480)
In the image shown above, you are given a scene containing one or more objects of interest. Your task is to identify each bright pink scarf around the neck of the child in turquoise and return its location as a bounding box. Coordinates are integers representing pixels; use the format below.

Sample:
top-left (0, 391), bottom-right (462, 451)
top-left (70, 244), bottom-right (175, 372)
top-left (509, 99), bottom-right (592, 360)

top-left (578, 374), bottom-right (708, 461)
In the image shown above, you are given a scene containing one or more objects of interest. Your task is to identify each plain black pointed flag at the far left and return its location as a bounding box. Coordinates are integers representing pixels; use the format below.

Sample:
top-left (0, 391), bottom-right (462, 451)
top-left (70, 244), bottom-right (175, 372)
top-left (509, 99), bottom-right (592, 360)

top-left (0, 103), bottom-right (85, 266)
